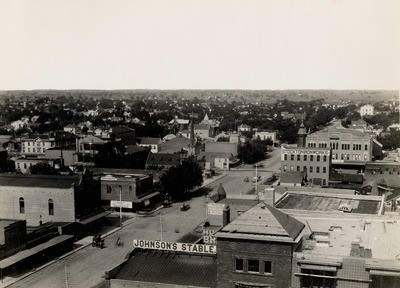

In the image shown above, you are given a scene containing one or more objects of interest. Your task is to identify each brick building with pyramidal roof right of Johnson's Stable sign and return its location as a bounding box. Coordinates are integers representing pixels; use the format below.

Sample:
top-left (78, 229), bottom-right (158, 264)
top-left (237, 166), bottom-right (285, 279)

top-left (216, 203), bottom-right (305, 288)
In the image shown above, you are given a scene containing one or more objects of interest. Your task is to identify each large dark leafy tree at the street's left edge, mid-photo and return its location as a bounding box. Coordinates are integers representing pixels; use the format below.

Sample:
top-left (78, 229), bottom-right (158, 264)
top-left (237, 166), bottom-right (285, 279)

top-left (160, 158), bottom-right (203, 199)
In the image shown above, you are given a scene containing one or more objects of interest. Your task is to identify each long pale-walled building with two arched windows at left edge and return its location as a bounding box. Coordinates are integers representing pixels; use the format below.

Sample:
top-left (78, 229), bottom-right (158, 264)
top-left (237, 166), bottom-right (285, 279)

top-left (0, 173), bottom-right (100, 226)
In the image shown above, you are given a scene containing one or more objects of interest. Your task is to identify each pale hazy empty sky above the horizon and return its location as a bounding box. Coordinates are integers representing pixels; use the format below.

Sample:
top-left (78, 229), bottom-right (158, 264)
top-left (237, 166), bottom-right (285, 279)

top-left (0, 0), bottom-right (400, 90)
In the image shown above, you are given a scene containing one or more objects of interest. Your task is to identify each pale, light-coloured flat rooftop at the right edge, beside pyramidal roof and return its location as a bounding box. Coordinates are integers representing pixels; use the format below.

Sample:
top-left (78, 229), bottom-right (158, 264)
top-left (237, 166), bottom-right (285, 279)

top-left (296, 215), bottom-right (400, 260)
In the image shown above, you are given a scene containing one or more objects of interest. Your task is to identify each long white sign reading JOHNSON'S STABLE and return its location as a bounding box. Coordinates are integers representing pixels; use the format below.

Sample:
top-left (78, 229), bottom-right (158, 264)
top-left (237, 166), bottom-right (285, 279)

top-left (133, 239), bottom-right (217, 254)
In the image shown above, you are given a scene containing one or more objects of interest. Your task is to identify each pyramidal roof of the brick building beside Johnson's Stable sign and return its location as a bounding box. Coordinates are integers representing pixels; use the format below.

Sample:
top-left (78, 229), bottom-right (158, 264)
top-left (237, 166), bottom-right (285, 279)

top-left (216, 203), bottom-right (305, 243)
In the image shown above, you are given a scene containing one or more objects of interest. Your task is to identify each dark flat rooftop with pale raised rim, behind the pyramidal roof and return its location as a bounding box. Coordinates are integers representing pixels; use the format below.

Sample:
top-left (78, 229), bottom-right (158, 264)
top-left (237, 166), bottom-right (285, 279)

top-left (275, 191), bottom-right (383, 214)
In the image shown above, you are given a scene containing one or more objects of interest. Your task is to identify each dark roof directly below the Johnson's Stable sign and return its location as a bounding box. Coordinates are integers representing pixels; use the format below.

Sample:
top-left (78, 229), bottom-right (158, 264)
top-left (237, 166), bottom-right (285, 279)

top-left (112, 248), bottom-right (217, 287)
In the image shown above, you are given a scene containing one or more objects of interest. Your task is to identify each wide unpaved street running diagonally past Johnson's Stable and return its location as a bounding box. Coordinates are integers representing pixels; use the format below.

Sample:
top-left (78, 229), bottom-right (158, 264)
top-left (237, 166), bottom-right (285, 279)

top-left (5, 148), bottom-right (280, 288)
